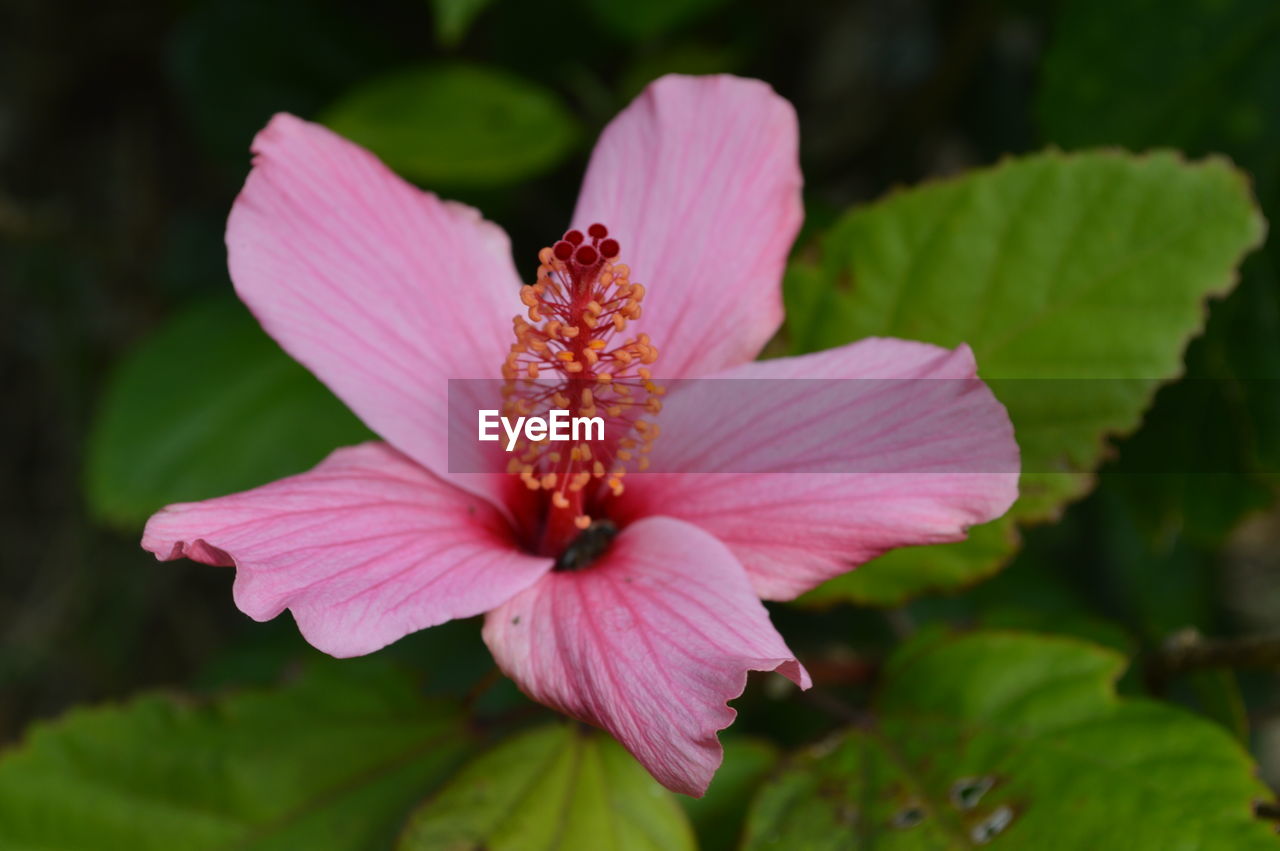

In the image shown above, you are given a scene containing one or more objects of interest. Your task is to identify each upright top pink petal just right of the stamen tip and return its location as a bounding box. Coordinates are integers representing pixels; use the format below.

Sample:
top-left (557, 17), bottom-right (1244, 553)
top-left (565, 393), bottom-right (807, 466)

top-left (573, 76), bottom-right (804, 376)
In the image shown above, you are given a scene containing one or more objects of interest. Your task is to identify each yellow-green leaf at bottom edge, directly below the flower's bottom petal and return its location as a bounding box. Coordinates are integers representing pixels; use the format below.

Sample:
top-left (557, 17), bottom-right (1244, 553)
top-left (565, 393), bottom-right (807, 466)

top-left (398, 724), bottom-right (694, 851)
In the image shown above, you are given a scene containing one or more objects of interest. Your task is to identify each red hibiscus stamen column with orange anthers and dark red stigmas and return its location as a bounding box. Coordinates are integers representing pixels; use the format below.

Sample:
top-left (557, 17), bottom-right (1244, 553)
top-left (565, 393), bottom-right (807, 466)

top-left (502, 224), bottom-right (663, 557)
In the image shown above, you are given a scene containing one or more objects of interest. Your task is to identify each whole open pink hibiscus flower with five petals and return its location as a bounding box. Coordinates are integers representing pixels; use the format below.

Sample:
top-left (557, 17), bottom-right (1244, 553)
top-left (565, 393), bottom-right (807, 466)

top-left (142, 77), bottom-right (1018, 795)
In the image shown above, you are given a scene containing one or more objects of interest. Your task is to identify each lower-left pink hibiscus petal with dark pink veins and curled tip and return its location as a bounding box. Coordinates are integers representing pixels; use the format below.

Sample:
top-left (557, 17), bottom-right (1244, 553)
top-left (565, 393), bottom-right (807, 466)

top-left (142, 443), bottom-right (552, 656)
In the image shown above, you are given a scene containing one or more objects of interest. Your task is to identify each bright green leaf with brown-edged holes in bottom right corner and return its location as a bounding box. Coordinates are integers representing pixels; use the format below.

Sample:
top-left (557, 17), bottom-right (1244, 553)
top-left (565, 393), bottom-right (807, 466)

top-left (745, 632), bottom-right (1276, 851)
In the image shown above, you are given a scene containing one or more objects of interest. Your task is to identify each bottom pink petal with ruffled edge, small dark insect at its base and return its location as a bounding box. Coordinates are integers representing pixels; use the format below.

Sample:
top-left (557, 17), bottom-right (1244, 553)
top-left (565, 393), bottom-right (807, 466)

top-left (484, 517), bottom-right (809, 796)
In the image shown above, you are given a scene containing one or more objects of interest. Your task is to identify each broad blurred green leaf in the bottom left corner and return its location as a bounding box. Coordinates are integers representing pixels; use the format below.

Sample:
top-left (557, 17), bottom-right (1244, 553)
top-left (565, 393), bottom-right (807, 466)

top-left (0, 663), bottom-right (468, 851)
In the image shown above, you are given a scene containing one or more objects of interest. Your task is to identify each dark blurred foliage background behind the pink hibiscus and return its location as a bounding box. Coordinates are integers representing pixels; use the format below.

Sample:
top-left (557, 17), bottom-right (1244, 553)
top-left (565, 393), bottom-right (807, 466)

top-left (0, 0), bottom-right (1280, 839)
